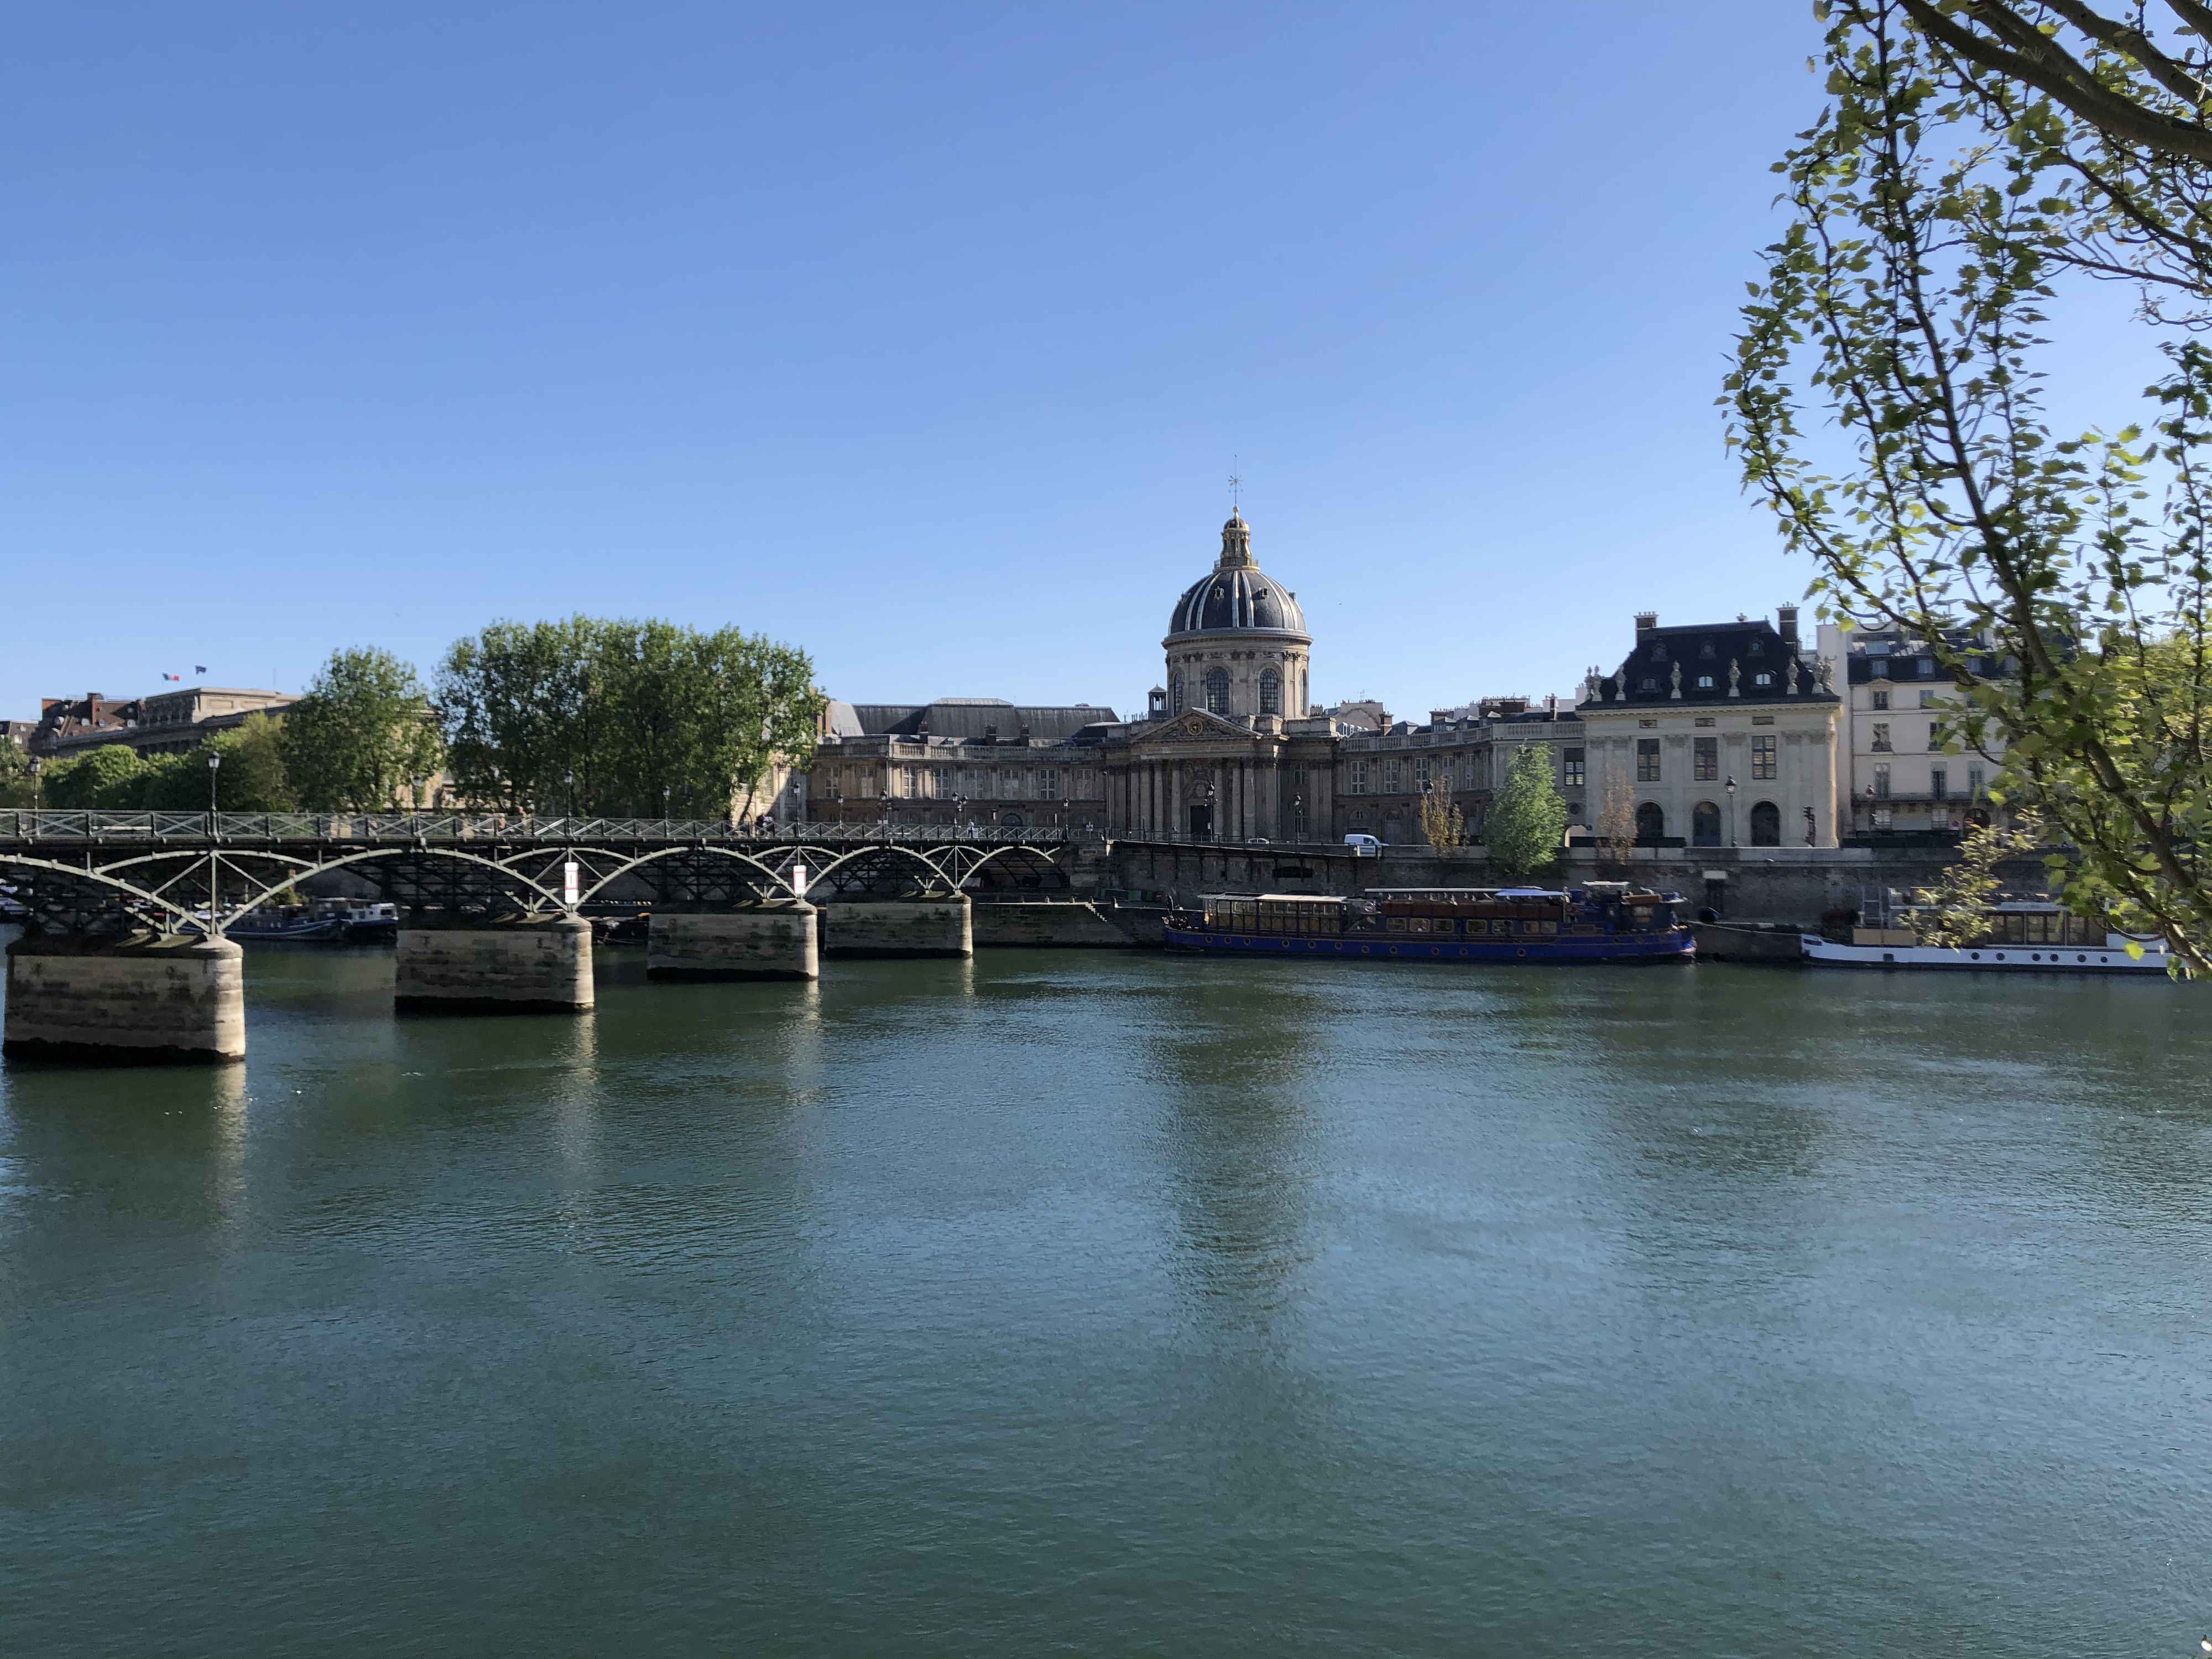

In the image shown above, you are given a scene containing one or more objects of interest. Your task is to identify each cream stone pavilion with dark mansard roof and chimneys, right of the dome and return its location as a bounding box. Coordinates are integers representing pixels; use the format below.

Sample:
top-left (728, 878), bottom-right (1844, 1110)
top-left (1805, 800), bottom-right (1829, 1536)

top-left (1577, 606), bottom-right (1840, 847)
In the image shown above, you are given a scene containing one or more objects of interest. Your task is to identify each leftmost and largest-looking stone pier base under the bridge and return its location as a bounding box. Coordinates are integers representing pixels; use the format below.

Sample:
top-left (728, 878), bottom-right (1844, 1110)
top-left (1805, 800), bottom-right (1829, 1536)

top-left (0, 933), bottom-right (246, 1066)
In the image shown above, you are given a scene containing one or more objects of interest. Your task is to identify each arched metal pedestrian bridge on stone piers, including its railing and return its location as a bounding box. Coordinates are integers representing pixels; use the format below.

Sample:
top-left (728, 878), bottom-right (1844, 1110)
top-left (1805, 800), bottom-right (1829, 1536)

top-left (0, 810), bottom-right (1099, 1062)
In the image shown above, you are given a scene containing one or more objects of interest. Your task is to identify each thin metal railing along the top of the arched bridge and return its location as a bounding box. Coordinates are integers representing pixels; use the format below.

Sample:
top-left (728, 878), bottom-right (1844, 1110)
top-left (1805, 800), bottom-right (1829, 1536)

top-left (0, 807), bottom-right (1104, 847)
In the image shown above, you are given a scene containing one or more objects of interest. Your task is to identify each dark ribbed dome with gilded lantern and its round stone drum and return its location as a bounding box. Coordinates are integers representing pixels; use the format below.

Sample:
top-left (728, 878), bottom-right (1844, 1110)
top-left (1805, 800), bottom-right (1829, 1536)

top-left (1152, 513), bottom-right (1314, 721)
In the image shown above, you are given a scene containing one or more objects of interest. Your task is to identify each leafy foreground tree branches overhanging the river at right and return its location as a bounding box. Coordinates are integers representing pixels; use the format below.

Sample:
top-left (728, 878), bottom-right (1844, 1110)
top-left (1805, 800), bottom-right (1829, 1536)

top-left (1728, 0), bottom-right (2212, 973)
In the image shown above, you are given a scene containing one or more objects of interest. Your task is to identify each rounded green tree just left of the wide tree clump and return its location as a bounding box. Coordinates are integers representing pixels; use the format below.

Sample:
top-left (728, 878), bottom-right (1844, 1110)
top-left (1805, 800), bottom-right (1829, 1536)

top-left (281, 646), bottom-right (445, 812)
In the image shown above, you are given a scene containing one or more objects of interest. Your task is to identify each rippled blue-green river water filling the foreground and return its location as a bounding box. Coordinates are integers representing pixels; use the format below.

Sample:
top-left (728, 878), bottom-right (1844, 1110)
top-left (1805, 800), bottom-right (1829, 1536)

top-left (0, 949), bottom-right (2212, 1659)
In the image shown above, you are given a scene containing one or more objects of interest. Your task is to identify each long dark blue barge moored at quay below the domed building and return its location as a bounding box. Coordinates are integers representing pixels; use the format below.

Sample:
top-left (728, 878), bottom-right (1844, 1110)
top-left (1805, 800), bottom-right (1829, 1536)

top-left (1168, 880), bottom-right (1697, 962)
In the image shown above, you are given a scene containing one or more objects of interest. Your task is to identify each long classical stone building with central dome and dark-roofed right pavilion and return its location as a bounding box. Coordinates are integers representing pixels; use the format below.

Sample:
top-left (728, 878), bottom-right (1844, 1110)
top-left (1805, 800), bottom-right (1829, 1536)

top-left (785, 513), bottom-right (1838, 845)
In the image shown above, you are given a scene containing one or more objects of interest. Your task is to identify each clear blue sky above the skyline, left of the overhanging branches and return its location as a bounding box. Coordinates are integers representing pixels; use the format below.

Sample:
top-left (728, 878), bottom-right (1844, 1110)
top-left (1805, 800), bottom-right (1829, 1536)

top-left (0, 0), bottom-right (2139, 717)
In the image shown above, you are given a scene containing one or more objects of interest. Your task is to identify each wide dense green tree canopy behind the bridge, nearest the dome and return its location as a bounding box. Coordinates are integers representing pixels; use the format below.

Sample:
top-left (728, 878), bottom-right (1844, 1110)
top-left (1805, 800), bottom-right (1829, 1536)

top-left (438, 617), bottom-right (823, 818)
